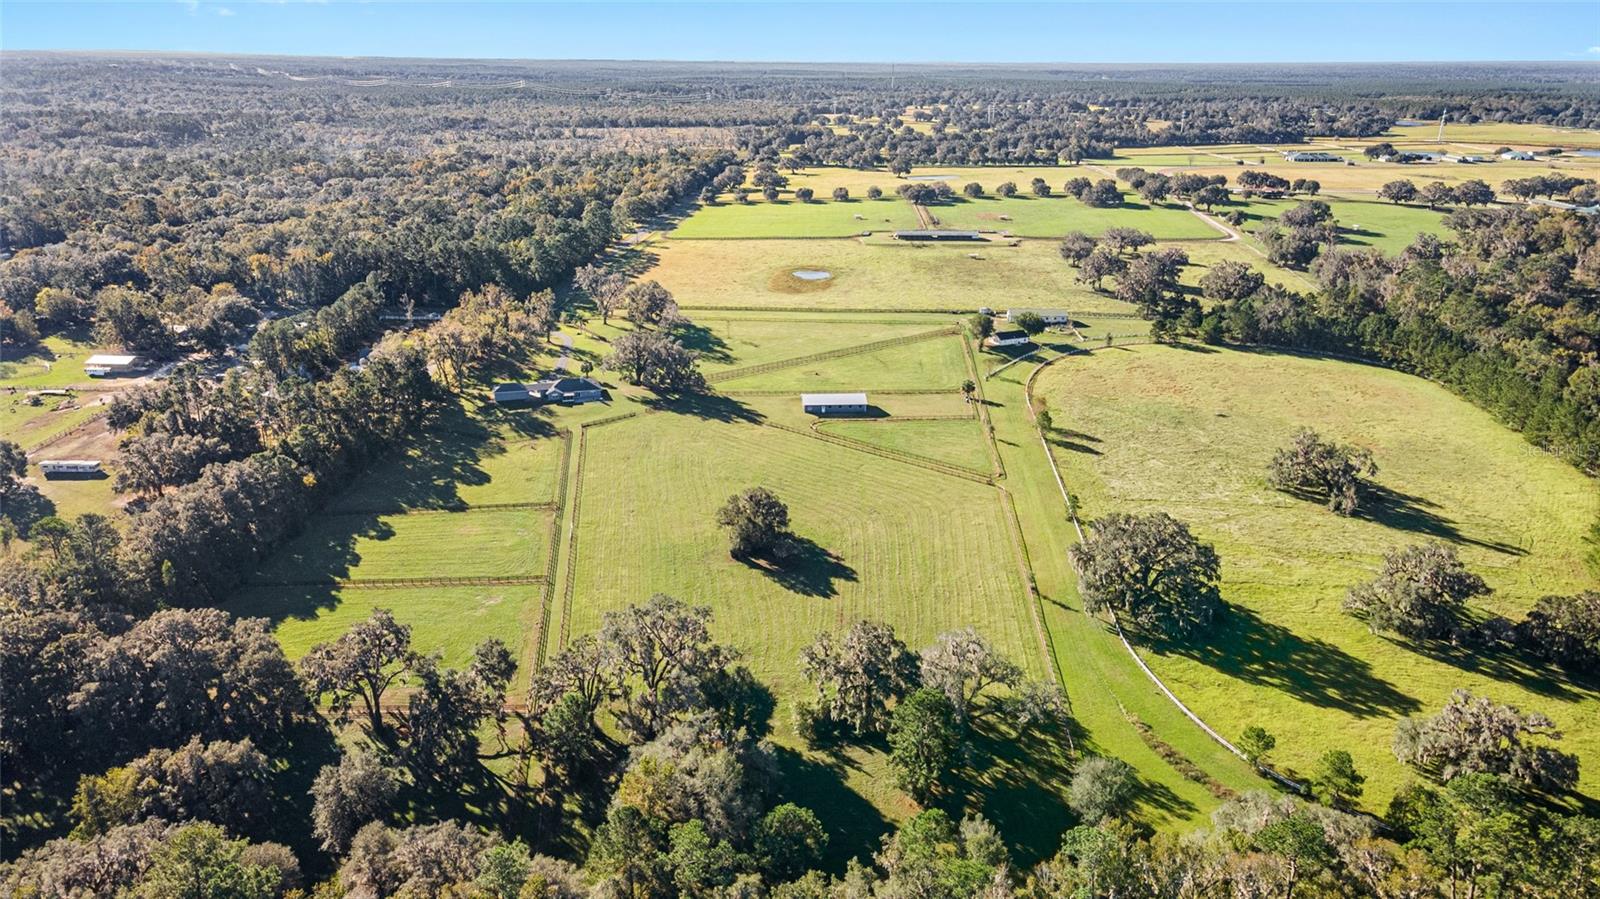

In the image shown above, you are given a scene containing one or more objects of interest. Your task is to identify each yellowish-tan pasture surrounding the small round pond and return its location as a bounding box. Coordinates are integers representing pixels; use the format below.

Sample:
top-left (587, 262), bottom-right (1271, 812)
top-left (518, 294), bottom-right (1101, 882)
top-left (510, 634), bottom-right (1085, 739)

top-left (645, 240), bottom-right (1131, 311)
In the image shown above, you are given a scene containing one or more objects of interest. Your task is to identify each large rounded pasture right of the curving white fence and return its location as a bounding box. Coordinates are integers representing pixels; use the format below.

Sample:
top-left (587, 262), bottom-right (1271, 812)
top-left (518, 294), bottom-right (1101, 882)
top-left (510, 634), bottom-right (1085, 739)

top-left (1037, 347), bottom-right (1600, 809)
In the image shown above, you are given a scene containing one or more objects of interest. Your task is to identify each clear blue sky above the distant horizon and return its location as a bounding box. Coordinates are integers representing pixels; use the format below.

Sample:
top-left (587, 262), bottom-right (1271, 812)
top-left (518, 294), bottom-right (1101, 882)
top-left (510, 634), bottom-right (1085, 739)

top-left (0, 0), bottom-right (1600, 62)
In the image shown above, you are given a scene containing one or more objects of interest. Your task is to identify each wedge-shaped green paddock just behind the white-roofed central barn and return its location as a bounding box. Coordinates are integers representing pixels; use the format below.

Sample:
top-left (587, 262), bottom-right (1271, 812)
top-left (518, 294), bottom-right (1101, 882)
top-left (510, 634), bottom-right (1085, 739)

top-left (718, 327), bottom-right (970, 387)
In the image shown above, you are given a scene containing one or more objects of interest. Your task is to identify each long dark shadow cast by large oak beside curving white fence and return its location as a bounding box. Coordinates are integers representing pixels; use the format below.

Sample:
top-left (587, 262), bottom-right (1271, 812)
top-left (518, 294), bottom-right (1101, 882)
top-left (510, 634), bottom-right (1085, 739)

top-left (1149, 605), bottom-right (1422, 718)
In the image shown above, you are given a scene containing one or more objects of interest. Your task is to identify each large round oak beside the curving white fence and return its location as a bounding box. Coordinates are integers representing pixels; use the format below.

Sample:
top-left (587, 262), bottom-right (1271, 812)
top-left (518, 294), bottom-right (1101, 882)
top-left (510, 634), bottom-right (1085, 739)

top-left (1070, 512), bottom-right (1222, 640)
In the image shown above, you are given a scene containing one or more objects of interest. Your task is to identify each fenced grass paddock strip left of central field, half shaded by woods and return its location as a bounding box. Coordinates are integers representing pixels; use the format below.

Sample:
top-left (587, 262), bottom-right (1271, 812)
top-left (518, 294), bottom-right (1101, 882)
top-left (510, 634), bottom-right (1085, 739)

top-left (226, 410), bottom-right (565, 665)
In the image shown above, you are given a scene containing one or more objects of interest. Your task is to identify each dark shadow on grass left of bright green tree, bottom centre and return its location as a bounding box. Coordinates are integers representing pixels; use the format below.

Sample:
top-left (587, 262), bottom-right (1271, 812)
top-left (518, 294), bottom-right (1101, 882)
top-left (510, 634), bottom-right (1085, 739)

top-left (774, 745), bottom-right (890, 873)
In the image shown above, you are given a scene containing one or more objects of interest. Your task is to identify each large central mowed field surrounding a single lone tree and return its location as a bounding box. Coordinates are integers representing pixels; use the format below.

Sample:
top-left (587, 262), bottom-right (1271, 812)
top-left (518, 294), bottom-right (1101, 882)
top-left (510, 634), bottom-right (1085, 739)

top-left (570, 413), bottom-right (1043, 700)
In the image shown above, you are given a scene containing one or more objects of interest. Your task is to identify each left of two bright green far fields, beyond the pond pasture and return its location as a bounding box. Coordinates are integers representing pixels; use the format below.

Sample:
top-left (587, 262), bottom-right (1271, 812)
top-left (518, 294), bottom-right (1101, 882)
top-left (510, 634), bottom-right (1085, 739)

top-left (672, 189), bottom-right (918, 240)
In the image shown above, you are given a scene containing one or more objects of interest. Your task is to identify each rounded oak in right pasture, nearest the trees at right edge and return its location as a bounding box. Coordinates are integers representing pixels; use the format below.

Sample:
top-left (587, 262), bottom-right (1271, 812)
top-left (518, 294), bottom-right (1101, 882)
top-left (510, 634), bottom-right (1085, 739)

top-left (1344, 542), bottom-right (1490, 640)
